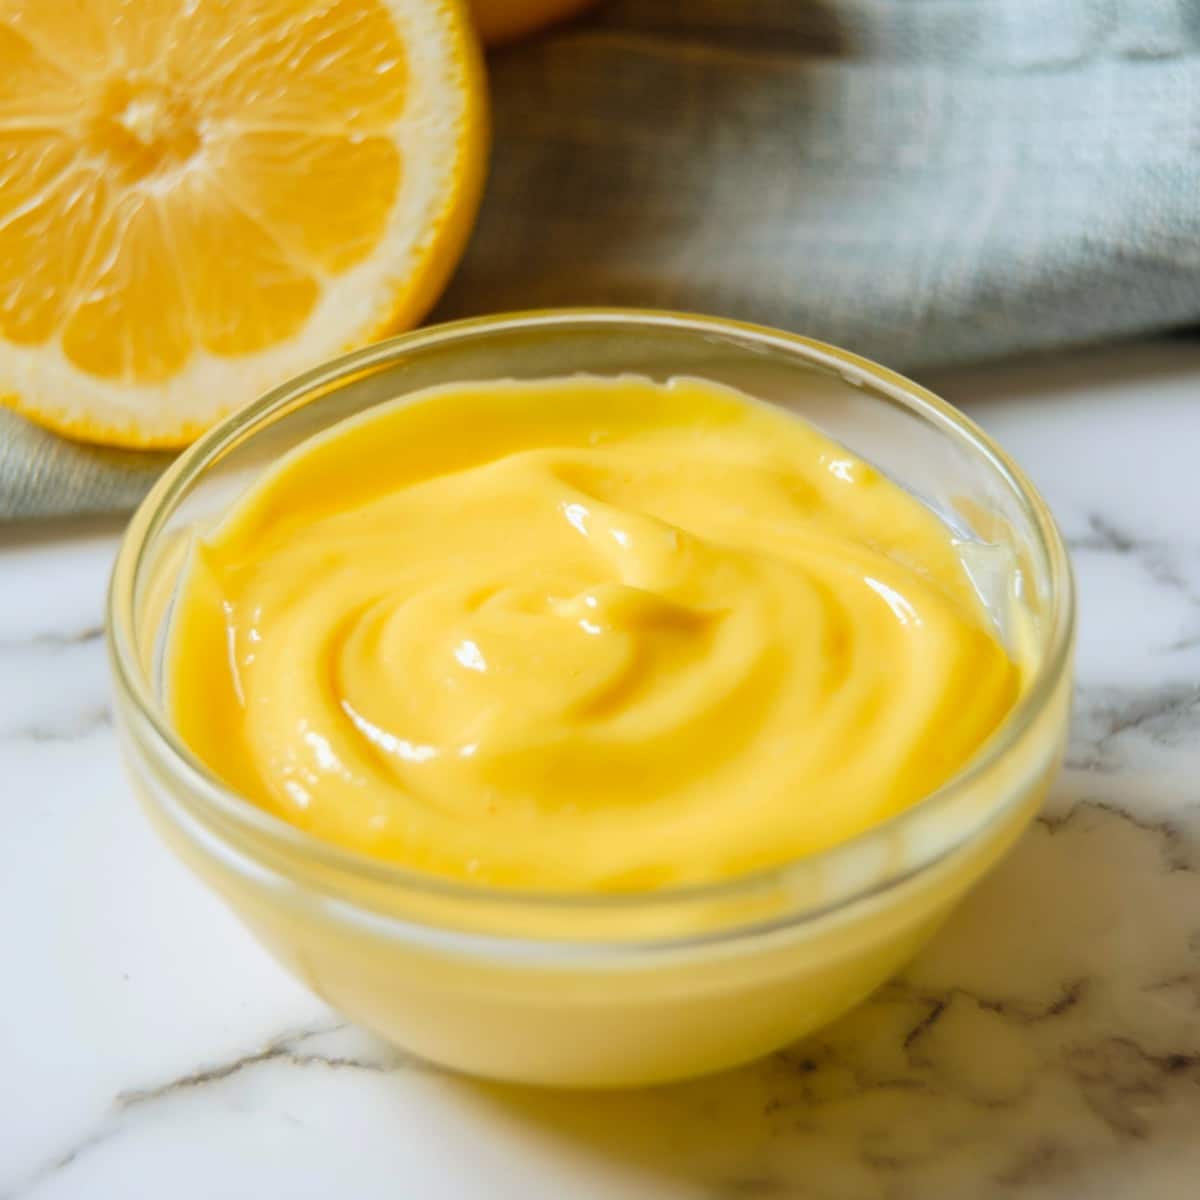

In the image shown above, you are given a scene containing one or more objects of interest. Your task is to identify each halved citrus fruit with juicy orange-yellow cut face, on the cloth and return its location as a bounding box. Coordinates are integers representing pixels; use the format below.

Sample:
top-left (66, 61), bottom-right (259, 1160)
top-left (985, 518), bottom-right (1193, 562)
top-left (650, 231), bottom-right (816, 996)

top-left (0, 0), bottom-right (486, 446)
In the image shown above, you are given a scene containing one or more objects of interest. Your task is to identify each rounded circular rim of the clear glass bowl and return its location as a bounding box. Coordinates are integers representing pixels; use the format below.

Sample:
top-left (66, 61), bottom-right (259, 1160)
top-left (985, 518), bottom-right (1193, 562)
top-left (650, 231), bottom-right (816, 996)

top-left (106, 307), bottom-right (1075, 946)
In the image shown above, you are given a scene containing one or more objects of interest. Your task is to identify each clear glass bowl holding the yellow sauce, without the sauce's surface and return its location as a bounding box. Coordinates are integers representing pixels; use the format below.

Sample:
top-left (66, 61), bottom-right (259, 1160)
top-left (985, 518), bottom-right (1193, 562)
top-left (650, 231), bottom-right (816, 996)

top-left (108, 311), bottom-right (1074, 1086)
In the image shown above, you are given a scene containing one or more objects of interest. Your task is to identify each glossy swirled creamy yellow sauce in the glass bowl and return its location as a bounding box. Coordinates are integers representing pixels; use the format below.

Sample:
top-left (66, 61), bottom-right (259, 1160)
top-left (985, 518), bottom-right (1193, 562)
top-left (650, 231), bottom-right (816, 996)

top-left (168, 377), bottom-right (1021, 892)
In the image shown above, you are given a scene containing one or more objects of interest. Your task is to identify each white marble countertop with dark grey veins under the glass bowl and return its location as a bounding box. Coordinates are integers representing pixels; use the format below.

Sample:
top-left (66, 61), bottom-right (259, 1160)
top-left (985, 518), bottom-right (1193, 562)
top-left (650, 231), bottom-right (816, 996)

top-left (0, 342), bottom-right (1200, 1200)
